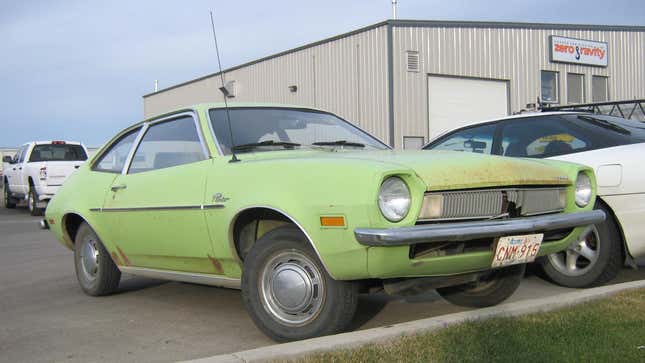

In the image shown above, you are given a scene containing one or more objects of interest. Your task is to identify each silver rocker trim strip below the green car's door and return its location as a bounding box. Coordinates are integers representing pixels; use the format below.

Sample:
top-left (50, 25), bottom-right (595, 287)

top-left (119, 266), bottom-right (241, 290)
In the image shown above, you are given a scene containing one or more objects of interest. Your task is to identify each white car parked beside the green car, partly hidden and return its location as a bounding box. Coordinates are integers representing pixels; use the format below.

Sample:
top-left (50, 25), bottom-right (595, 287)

top-left (423, 112), bottom-right (645, 287)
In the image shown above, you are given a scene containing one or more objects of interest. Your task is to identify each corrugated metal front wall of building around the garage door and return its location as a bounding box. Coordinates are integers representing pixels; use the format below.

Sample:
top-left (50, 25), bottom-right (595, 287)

top-left (393, 26), bottom-right (645, 147)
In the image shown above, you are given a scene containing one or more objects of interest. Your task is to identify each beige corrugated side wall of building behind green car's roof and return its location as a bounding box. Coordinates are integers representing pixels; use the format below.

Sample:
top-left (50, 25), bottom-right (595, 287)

top-left (144, 26), bottom-right (388, 142)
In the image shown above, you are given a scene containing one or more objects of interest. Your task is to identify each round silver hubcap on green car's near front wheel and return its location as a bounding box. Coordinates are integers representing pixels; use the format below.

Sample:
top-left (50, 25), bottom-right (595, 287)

top-left (260, 251), bottom-right (325, 326)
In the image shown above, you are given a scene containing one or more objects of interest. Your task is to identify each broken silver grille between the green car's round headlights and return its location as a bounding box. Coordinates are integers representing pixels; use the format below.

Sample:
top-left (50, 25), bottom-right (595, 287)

top-left (419, 188), bottom-right (566, 221)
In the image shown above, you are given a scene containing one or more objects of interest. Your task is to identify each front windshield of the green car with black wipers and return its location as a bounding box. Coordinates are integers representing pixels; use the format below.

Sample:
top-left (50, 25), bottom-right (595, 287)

top-left (209, 107), bottom-right (388, 155)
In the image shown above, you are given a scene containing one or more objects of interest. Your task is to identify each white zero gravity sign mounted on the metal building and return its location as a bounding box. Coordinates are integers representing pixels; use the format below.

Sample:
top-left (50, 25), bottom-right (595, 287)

top-left (550, 35), bottom-right (608, 67)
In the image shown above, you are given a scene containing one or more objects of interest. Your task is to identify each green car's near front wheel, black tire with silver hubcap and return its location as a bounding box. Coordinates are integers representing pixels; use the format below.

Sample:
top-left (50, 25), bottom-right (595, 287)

top-left (242, 226), bottom-right (358, 342)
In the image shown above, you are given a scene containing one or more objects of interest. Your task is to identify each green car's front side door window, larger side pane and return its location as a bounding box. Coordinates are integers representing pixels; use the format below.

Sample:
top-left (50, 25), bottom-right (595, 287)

top-left (128, 116), bottom-right (206, 174)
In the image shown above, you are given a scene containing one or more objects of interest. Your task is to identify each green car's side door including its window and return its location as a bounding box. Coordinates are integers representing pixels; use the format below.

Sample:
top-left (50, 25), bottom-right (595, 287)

top-left (103, 113), bottom-right (213, 273)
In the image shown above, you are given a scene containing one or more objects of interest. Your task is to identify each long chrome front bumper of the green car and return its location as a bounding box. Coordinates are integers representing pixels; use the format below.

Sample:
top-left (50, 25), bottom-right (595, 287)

top-left (354, 210), bottom-right (605, 247)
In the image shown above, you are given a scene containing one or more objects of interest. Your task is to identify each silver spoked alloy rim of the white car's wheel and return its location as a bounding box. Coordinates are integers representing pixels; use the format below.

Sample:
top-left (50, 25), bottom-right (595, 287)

top-left (549, 226), bottom-right (600, 276)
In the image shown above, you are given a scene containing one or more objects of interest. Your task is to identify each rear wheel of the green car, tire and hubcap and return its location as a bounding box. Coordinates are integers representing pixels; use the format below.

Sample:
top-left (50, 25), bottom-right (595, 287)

top-left (74, 223), bottom-right (121, 296)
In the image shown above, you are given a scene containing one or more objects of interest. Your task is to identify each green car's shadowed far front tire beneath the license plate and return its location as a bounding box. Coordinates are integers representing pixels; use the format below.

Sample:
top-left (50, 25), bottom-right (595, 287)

top-left (437, 264), bottom-right (526, 308)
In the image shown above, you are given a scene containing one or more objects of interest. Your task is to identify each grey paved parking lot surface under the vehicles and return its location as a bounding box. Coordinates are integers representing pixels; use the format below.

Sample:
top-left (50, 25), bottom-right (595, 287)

top-left (0, 202), bottom-right (645, 362)
